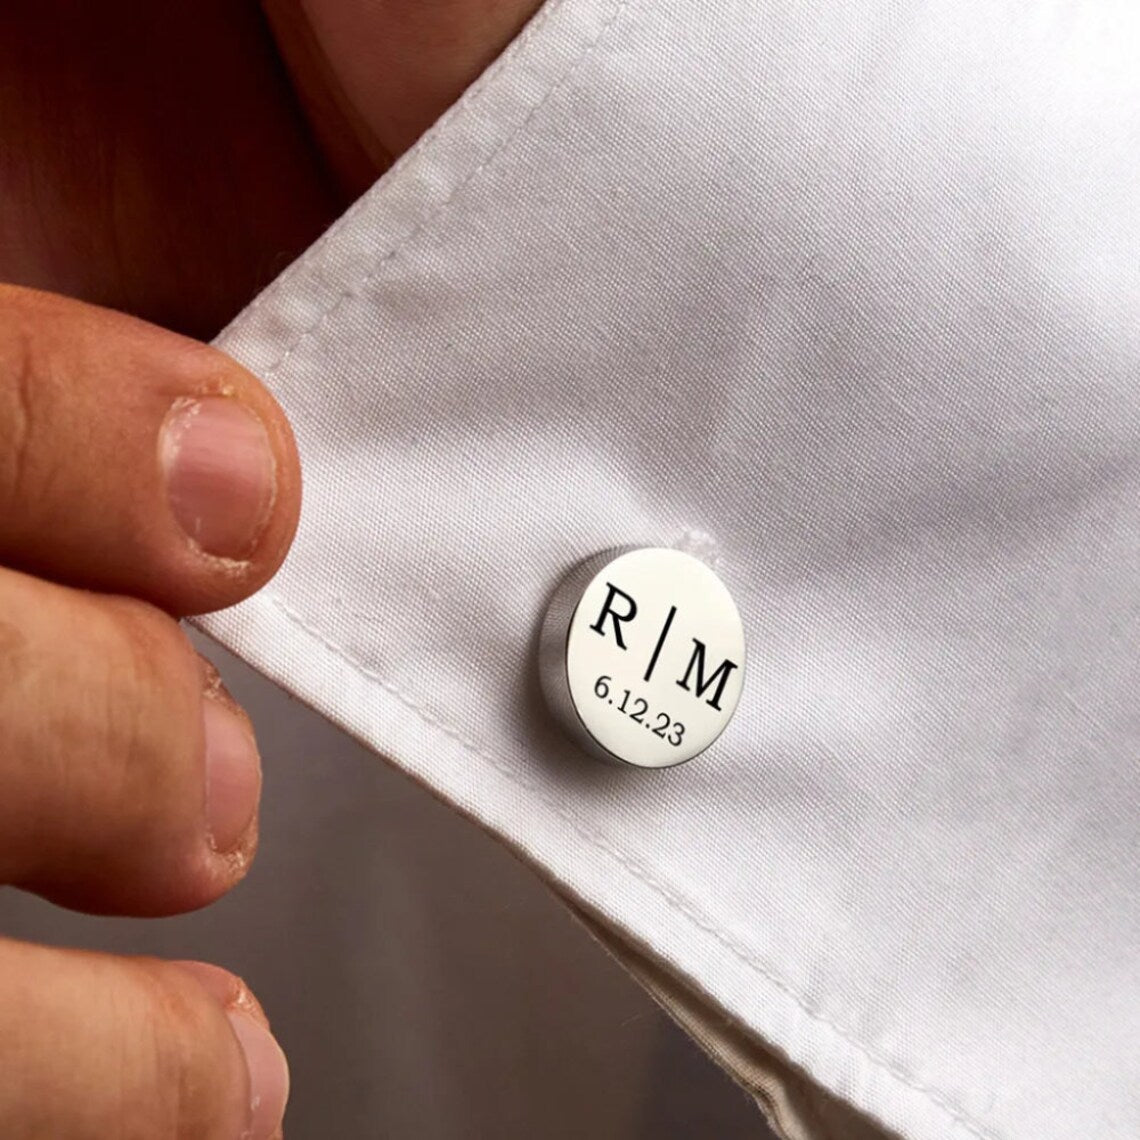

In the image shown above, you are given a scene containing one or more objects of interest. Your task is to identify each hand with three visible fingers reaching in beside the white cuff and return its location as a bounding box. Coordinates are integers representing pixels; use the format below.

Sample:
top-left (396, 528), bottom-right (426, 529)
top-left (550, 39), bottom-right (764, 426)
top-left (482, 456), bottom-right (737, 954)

top-left (0, 286), bottom-right (300, 1140)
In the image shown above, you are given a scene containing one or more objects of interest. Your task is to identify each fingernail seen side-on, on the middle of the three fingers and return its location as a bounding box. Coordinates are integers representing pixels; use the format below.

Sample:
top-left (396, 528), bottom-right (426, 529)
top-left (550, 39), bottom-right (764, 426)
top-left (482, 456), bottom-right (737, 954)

top-left (202, 695), bottom-right (261, 853)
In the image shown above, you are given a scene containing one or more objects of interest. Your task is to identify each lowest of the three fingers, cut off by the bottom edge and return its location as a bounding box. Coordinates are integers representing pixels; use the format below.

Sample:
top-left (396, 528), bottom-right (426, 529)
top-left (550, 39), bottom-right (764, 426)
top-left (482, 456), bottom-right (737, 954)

top-left (0, 939), bottom-right (264, 1140)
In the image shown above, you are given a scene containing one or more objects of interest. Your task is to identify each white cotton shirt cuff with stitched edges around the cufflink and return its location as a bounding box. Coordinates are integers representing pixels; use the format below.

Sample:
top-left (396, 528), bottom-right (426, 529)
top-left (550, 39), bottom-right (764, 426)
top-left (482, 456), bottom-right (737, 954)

top-left (207, 0), bottom-right (1140, 1140)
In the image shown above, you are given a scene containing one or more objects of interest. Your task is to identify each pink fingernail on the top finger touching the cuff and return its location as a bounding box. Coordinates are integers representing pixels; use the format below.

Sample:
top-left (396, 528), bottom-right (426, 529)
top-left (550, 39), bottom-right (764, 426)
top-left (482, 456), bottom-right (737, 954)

top-left (161, 396), bottom-right (277, 559)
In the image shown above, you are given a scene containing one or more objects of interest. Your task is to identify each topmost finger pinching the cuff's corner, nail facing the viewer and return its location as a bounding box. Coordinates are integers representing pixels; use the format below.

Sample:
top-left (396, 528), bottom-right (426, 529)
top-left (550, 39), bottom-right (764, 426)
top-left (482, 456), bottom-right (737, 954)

top-left (0, 288), bottom-right (301, 616)
